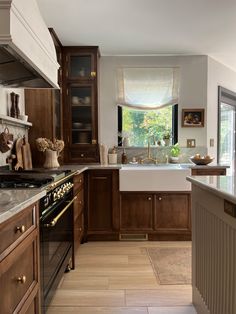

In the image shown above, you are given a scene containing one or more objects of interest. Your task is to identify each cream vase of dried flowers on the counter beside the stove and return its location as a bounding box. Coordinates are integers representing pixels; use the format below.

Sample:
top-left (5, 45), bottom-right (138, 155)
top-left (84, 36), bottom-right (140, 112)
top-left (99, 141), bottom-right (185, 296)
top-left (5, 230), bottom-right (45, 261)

top-left (36, 137), bottom-right (64, 168)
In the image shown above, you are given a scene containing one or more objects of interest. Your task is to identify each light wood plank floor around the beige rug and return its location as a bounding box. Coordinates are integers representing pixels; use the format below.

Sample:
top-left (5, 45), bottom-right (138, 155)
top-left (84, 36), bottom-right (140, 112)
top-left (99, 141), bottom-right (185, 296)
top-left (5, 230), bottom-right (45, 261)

top-left (48, 241), bottom-right (196, 314)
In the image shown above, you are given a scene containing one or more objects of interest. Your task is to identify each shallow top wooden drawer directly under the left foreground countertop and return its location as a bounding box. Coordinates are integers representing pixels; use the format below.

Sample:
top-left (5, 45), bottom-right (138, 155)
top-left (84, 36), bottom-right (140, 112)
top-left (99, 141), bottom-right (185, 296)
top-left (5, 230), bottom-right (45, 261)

top-left (0, 204), bottom-right (37, 261)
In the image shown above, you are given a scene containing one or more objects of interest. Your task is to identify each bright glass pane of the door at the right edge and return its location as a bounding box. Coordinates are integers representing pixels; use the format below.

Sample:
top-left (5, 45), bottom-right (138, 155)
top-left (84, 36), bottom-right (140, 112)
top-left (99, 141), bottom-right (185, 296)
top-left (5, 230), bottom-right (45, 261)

top-left (219, 103), bottom-right (235, 167)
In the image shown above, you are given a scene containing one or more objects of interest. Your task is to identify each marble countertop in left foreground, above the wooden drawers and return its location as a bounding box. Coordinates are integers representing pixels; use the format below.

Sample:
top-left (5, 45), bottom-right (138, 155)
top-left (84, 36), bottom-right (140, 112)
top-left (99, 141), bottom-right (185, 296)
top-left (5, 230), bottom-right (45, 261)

top-left (0, 189), bottom-right (46, 223)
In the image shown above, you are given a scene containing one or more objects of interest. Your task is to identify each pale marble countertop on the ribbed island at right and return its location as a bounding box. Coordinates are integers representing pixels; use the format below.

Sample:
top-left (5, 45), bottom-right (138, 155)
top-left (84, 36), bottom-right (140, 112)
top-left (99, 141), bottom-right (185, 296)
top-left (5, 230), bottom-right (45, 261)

top-left (187, 176), bottom-right (236, 204)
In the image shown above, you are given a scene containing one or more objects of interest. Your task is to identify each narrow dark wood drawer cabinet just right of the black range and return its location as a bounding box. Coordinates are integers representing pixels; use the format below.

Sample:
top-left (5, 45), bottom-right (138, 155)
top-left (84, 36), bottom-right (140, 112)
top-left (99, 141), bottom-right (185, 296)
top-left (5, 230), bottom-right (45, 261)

top-left (73, 173), bottom-right (84, 255)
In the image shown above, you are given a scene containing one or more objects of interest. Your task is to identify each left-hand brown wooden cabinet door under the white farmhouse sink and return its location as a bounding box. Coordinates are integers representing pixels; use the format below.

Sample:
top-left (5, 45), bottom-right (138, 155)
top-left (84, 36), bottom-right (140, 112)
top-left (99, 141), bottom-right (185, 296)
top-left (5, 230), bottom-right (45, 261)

top-left (120, 192), bottom-right (154, 231)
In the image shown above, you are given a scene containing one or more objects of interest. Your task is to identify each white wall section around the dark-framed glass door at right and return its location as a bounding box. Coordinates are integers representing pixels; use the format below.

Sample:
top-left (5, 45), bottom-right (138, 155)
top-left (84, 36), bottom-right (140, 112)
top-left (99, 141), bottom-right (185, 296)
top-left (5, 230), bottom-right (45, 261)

top-left (207, 57), bottom-right (236, 157)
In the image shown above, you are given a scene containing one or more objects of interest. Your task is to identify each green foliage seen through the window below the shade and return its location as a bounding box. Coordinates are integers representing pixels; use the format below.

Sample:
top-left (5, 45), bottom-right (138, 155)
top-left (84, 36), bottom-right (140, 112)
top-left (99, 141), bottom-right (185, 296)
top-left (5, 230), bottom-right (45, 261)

top-left (122, 106), bottom-right (172, 147)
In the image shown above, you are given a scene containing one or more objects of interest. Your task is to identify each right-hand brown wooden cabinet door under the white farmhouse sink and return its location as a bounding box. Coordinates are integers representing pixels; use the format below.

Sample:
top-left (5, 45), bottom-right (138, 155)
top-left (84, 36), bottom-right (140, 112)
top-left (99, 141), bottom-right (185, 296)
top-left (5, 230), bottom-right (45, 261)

top-left (155, 193), bottom-right (190, 232)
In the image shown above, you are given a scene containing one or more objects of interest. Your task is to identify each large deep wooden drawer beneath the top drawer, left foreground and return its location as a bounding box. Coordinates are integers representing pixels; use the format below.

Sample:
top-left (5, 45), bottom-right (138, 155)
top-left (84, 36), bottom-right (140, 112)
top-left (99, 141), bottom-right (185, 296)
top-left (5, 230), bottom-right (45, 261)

top-left (0, 230), bottom-right (38, 314)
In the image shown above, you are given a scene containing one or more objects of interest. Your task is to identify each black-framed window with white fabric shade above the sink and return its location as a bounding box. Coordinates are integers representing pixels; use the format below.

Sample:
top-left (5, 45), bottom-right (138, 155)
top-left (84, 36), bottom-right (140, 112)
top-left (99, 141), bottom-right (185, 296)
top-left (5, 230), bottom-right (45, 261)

top-left (117, 68), bottom-right (179, 147)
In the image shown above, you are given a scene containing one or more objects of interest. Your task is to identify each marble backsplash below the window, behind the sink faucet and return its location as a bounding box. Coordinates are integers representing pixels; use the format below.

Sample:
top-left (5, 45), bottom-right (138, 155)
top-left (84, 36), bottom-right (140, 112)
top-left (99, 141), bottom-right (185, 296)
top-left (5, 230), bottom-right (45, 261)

top-left (113, 146), bottom-right (207, 163)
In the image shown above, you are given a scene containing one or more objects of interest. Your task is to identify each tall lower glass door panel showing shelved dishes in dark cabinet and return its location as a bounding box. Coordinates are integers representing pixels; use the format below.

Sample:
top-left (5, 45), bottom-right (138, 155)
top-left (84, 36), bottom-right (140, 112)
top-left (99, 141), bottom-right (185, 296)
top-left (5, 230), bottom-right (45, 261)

top-left (68, 83), bottom-right (96, 145)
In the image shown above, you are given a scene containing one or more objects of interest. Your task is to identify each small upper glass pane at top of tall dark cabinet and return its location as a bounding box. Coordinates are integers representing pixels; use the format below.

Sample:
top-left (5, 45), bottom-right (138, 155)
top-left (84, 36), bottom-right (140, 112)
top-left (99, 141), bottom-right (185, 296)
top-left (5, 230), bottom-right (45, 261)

top-left (70, 56), bottom-right (92, 77)
